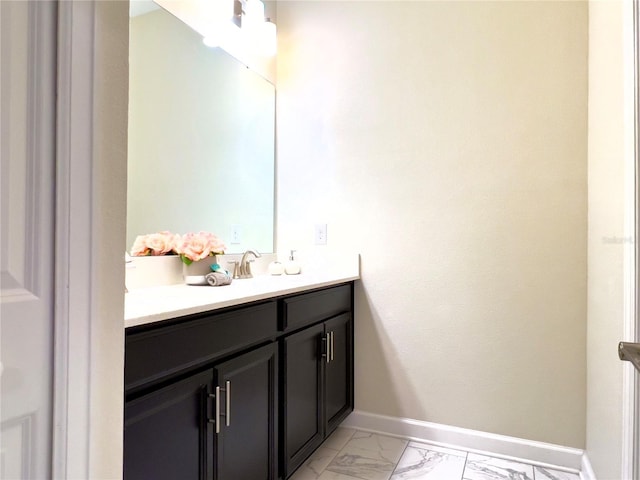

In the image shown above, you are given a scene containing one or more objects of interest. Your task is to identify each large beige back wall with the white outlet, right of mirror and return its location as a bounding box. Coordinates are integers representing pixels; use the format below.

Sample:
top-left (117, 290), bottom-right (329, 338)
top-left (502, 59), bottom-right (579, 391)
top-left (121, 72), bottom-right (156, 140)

top-left (277, 1), bottom-right (588, 447)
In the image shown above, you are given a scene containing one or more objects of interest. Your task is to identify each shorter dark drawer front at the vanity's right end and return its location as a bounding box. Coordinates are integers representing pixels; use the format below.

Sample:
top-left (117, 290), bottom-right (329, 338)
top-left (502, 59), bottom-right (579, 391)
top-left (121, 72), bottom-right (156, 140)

top-left (280, 284), bottom-right (352, 331)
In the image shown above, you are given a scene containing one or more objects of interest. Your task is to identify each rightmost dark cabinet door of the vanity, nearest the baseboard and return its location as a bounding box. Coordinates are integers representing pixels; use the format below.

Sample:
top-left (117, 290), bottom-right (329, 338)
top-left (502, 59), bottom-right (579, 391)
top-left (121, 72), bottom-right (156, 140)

top-left (325, 313), bottom-right (353, 435)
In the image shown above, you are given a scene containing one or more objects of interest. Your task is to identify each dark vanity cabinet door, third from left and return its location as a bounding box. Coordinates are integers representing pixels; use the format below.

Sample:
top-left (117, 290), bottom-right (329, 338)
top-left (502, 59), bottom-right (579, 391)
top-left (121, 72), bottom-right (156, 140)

top-left (283, 324), bottom-right (324, 477)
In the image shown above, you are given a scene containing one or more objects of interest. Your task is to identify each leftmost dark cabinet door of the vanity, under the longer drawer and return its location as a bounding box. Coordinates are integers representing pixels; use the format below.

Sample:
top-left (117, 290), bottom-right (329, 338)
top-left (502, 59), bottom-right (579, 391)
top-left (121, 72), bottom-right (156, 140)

top-left (124, 370), bottom-right (213, 480)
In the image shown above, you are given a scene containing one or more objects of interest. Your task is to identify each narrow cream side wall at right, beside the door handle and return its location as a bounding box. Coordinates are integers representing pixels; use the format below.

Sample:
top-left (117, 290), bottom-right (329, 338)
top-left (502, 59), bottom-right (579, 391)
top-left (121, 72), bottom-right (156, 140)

top-left (587, 1), bottom-right (633, 480)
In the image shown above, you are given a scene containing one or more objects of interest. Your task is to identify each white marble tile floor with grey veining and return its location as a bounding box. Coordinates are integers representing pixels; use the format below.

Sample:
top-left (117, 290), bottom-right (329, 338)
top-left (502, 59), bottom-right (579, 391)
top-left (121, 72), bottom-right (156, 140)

top-left (290, 427), bottom-right (580, 480)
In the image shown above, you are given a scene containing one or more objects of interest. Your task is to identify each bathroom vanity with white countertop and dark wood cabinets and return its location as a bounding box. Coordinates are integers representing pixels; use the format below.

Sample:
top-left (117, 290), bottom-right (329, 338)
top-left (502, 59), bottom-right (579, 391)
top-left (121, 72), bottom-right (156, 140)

top-left (124, 275), bottom-right (356, 480)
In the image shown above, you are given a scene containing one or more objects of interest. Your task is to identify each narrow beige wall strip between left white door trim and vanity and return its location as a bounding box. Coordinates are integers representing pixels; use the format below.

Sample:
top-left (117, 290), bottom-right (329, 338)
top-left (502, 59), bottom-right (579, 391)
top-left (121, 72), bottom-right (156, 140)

top-left (92, 1), bottom-right (129, 479)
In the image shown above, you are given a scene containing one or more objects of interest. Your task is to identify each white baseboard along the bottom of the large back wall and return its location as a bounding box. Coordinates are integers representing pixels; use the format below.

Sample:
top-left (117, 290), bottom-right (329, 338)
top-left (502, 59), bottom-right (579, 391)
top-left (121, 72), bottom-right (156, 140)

top-left (342, 410), bottom-right (584, 472)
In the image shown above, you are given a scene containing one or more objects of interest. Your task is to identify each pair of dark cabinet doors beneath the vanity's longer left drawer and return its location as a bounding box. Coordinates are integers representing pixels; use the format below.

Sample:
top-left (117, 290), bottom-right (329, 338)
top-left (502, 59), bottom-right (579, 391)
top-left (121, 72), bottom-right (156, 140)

top-left (124, 343), bottom-right (278, 480)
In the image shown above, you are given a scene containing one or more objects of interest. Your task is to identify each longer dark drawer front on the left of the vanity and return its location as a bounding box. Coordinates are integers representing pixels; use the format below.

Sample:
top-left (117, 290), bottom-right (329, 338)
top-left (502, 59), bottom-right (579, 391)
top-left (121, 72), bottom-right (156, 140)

top-left (125, 302), bottom-right (278, 391)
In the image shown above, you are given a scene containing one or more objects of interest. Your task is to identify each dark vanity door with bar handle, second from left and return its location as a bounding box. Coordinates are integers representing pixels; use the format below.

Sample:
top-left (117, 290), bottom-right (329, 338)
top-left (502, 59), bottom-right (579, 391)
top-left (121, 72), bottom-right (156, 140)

top-left (215, 343), bottom-right (278, 480)
